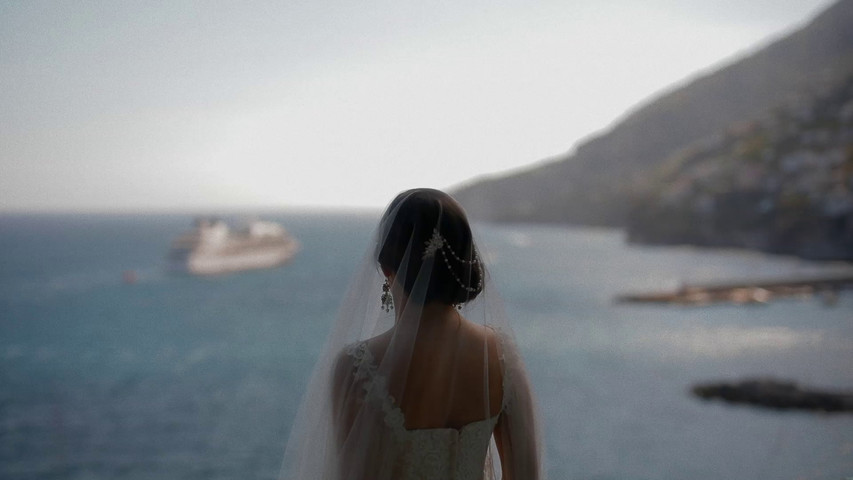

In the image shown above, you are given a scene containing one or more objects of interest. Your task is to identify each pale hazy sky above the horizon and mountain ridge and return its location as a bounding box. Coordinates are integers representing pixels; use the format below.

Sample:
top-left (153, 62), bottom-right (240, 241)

top-left (0, 0), bottom-right (832, 212)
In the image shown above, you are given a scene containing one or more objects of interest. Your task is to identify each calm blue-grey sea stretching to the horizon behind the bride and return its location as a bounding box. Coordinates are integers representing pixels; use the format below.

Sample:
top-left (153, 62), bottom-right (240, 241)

top-left (0, 211), bottom-right (853, 480)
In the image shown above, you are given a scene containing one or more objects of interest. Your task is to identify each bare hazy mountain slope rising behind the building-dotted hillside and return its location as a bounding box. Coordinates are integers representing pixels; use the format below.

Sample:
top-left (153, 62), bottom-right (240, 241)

top-left (453, 0), bottom-right (853, 236)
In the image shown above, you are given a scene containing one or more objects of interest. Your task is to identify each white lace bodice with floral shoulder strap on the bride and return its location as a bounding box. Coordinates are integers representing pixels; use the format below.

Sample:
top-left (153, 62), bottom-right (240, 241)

top-left (347, 342), bottom-right (506, 480)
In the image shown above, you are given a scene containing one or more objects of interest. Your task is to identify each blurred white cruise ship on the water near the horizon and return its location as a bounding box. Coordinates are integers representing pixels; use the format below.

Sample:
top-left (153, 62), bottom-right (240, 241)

top-left (168, 219), bottom-right (299, 275)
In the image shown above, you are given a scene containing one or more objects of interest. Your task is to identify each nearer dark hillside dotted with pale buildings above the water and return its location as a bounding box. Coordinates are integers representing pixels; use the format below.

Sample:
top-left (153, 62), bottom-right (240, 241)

top-left (627, 75), bottom-right (853, 260)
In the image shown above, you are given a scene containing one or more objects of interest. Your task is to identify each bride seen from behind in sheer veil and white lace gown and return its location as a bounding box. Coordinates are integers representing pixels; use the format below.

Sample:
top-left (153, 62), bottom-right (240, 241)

top-left (281, 189), bottom-right (541, 480)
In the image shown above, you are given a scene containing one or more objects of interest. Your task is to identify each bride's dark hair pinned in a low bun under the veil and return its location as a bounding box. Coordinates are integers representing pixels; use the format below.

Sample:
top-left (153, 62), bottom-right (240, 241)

top-left (376, 188), bottom-right (483, 305)
